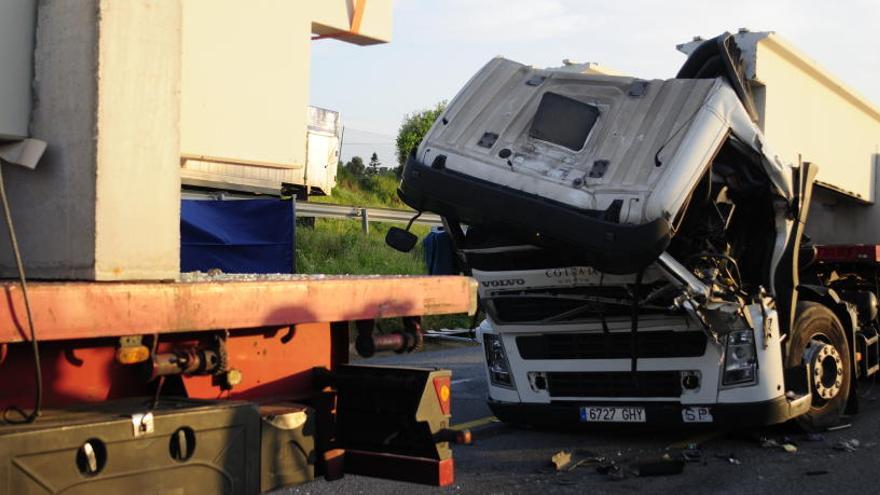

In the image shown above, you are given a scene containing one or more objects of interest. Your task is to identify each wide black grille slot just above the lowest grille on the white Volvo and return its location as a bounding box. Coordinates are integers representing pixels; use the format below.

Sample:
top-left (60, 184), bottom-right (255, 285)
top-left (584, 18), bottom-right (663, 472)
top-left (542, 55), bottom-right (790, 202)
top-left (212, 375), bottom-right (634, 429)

top-left (516, 330), bottom-right (706, 359)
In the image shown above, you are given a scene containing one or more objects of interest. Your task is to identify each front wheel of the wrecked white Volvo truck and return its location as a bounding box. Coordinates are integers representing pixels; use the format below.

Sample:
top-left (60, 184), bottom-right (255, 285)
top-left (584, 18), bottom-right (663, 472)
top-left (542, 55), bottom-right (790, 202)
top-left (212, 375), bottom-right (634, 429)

top-left (786, 302), bottom-right (852, 431)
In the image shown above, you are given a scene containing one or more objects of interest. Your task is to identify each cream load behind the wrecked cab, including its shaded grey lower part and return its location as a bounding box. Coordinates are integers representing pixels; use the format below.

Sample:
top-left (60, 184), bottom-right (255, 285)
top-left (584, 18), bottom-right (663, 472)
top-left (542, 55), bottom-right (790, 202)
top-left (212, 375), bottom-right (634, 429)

top-left (678, 31), bottom-right (880, 244)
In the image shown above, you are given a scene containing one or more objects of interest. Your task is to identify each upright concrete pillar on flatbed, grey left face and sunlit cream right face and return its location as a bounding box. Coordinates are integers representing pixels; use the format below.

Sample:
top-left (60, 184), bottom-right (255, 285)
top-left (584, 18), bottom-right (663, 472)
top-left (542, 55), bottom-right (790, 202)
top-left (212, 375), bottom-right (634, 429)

top-left (0, 0), bottom-right (181, 280)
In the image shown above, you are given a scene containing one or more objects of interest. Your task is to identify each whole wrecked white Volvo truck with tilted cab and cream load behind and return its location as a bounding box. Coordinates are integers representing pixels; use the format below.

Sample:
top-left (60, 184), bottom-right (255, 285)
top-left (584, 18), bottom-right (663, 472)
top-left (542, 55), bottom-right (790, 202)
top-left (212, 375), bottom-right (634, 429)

top-left (400, 31), bottom-right (880, 430)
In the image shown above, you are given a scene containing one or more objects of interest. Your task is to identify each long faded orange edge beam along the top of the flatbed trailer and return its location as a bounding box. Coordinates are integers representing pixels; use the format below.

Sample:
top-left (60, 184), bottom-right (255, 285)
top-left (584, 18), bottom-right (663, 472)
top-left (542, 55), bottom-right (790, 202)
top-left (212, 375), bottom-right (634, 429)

top-left (0, 276), bottom-right (476, 343)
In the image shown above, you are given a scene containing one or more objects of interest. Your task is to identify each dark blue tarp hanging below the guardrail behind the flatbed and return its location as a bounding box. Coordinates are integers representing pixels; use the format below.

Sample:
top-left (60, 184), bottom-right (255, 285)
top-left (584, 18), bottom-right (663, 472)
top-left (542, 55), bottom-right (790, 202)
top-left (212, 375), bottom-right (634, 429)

top-left (180, 199), bottom-right (294, 273)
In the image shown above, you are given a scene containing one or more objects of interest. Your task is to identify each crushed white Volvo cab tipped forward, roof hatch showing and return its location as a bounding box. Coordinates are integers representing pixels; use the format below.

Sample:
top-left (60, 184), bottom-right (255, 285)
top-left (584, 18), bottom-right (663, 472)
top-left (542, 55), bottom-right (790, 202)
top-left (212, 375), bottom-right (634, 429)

top-left (400, 58), bottom-right (791, 273)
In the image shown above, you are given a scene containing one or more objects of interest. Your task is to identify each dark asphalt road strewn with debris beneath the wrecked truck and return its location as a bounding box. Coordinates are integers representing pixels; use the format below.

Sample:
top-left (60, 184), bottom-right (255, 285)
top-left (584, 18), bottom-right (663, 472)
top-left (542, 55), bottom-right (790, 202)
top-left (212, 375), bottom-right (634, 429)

top-left (286, 347), bottom-right (880, 495)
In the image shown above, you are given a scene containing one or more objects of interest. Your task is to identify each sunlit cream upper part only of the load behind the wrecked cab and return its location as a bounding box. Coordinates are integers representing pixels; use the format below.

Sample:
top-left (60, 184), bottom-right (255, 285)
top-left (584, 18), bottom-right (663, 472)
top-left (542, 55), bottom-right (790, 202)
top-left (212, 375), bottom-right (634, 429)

top-left (678, 31), bottom-right (880, 203)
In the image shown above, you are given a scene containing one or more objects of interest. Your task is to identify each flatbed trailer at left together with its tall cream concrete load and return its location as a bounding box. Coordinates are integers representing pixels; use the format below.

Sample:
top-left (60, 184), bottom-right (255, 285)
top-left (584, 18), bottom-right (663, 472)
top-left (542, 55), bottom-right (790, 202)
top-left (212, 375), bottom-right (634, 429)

top-left (0, 0), bottom-right (476, 495)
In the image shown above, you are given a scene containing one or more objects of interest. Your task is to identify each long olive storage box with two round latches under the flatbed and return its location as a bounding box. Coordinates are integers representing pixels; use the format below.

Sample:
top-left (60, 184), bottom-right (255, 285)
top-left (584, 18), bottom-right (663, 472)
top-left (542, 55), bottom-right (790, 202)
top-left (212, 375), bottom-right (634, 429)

top-left (0, 399), bottom-right (260, 495)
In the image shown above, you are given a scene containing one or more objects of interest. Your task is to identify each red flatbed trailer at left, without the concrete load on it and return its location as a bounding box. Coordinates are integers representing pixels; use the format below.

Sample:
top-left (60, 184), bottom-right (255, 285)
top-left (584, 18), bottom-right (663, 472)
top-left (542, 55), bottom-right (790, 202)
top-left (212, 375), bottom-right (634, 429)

top-left (0, 276), bottom-right (476, 493)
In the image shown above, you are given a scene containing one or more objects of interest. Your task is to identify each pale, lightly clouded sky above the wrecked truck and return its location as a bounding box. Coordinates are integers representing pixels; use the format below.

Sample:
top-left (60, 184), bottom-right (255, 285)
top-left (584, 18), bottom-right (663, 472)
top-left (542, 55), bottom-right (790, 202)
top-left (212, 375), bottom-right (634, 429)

top-left (310, 0), bottom-right (880, 166)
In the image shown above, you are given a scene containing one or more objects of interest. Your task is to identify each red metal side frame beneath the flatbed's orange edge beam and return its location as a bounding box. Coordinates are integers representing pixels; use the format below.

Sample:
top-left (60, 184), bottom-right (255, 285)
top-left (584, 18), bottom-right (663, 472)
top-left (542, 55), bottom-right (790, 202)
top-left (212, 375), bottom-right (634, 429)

top-left (0, 323), bottom-right (348, 409)
